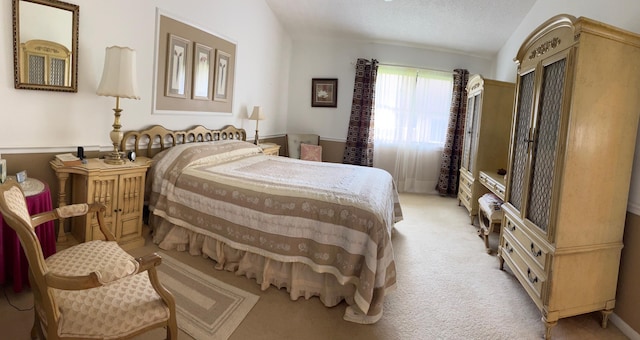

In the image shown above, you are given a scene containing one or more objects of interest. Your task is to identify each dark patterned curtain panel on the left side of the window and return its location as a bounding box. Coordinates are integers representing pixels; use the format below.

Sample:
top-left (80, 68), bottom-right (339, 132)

top-left (342, 59), bottom-right (378, 167)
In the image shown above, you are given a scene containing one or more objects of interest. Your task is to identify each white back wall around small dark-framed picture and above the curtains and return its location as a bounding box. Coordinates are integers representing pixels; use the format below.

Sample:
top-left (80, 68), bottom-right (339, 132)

top-left (286, 41), bottom-right (494, 142)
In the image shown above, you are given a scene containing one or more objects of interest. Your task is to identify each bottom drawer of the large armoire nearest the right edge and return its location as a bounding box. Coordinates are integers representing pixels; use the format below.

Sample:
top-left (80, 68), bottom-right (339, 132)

top-left (500, 233), bottom-right (546, 303)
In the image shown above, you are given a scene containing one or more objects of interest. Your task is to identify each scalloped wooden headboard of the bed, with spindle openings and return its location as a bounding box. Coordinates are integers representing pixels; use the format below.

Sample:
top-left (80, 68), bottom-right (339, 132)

top-left (120, 125), bottom-right (247, 157)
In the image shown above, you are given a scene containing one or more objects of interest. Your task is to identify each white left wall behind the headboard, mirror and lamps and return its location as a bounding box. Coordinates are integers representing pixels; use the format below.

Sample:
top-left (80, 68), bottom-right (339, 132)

top-left (0, 0), bottom-right (291, 153)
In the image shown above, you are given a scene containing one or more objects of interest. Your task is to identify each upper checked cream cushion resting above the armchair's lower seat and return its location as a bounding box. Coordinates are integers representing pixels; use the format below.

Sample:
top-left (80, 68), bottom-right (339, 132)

top-left (45, 240), bottom-right (139, 284)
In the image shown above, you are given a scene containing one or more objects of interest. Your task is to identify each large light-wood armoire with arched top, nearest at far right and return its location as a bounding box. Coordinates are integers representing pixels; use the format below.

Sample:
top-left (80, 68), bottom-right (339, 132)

top-left (498, 15), bottom-right (640, 339)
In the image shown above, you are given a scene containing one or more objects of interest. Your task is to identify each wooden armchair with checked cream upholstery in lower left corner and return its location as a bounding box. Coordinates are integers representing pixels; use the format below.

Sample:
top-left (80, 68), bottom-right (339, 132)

top-left (0, 181), bottom-right (177, 339)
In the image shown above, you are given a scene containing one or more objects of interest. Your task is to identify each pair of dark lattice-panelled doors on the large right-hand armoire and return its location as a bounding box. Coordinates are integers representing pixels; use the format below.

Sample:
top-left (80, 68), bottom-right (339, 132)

top-left (509, 57), bottom-right (567, 233)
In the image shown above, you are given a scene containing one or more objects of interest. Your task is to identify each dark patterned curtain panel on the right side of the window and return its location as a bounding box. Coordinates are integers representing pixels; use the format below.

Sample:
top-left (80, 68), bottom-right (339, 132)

top-left (436, 69), bottom-right (469, 197)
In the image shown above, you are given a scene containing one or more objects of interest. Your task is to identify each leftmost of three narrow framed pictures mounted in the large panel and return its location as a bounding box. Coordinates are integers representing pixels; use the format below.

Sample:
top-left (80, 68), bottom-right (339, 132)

top-left (165, 34), bottom-right (190, 98)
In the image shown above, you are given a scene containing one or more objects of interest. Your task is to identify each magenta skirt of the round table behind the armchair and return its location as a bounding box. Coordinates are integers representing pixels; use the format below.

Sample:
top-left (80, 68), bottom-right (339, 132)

top-left (0, 183), bottom-right (56, 292)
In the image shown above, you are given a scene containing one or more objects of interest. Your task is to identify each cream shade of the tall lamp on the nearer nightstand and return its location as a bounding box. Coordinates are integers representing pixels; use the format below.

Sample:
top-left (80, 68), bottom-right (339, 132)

top-left (96, 46), bottom-right (140, 99)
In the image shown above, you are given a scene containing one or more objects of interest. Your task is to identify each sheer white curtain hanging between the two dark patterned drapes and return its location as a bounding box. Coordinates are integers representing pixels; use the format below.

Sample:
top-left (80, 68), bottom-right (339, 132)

top-left (373, 65), bottom-right (453, 193)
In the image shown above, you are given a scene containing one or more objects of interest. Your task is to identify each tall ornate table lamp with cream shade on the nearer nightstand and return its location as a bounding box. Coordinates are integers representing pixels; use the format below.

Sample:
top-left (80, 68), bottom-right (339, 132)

top-left (96, 46), bottom-right (140, 164)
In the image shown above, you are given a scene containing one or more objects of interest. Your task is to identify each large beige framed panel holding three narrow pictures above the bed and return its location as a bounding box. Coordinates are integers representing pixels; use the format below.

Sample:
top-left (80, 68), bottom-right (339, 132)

top-left (152, 8), bottom-right (237, 115)
